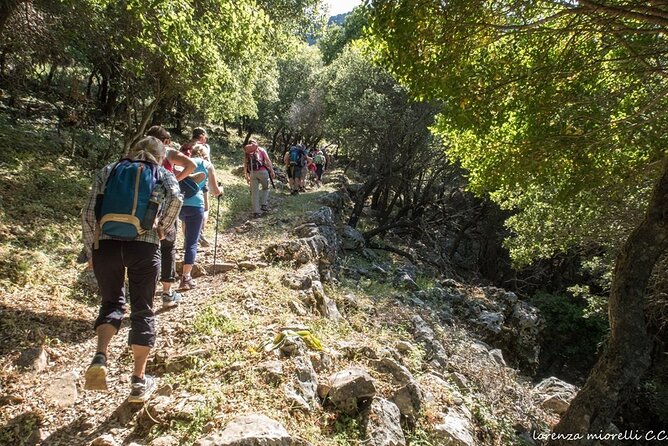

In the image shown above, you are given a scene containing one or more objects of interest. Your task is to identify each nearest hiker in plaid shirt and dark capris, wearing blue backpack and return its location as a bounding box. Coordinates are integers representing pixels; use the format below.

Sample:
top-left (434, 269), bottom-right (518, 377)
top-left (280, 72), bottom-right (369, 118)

top-left (82, 136), bottom-right (181, 402)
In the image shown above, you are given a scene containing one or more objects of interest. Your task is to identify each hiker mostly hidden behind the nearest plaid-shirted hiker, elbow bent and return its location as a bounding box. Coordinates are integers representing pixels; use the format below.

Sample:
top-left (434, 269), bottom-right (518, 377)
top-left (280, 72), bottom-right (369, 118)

top-left (146, 125), bottom-right (200, 308)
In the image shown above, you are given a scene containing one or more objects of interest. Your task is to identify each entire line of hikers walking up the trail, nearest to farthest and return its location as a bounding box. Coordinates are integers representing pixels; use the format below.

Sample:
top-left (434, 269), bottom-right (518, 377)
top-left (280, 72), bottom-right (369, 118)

top-left (82, 126), bottom-right (327, 403)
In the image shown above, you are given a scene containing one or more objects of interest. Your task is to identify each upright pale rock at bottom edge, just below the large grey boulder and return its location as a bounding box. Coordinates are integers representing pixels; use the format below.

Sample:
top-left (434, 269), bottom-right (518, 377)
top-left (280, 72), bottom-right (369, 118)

top-left (363, 398), bottom-right (406, 446)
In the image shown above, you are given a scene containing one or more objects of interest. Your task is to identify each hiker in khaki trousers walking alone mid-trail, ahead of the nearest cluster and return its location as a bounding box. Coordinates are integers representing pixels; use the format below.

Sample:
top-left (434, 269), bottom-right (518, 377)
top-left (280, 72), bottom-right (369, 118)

top-left (244, 139), bottom-right (276, 218)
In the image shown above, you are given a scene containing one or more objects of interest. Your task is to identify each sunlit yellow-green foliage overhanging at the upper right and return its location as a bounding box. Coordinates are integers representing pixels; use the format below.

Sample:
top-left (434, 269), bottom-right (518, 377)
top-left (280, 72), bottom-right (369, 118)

top-left (370, 0), bottom-right (668, 263)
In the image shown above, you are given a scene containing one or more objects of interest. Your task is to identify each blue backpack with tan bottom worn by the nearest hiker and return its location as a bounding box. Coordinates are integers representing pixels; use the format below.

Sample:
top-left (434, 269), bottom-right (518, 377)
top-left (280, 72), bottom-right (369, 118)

top-left (95, 159), bottom-right (162, 240)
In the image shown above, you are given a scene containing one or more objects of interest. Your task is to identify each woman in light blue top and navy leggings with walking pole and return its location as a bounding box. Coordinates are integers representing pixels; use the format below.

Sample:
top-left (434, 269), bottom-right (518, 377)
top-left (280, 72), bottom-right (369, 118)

top-left (179, 144), bottom-right (223, 291)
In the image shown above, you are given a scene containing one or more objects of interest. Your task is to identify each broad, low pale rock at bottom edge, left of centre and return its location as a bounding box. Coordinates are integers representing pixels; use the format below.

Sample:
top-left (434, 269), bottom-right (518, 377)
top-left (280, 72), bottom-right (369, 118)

top-left (195, 414), bottom-right (295, 446)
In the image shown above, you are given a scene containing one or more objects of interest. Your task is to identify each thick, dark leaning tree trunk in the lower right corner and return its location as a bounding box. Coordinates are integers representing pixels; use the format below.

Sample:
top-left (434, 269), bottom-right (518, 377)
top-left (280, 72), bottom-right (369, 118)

top-left (549, 160), bottom-right (668, 446)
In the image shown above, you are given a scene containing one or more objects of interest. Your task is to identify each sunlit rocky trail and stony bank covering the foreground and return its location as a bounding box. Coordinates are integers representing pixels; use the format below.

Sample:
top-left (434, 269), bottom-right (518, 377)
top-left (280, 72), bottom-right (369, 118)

top-left (0, 176), bottom-right (575, 446)
